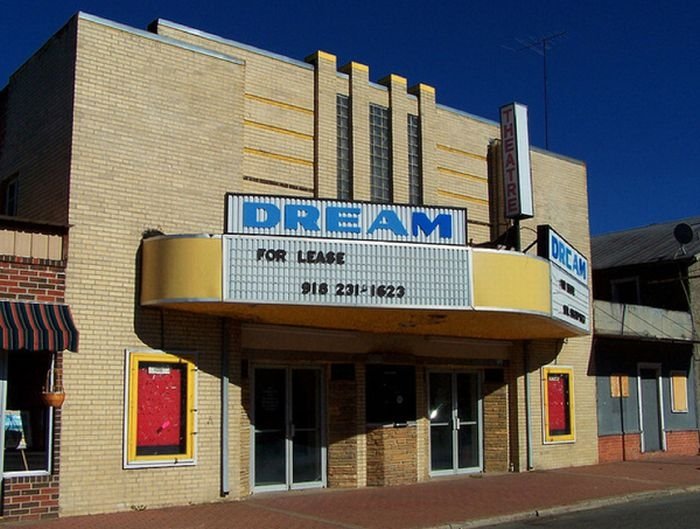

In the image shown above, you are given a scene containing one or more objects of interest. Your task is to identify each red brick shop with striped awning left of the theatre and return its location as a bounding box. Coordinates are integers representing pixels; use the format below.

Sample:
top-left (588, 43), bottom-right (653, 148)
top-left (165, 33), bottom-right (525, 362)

top-left (0, 217), bottom-right (78, 520)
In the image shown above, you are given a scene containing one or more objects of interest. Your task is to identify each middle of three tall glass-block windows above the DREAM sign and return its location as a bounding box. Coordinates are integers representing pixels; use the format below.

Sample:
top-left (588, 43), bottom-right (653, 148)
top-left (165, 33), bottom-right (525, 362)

top-left (369, 105), bottom-right (393, 202)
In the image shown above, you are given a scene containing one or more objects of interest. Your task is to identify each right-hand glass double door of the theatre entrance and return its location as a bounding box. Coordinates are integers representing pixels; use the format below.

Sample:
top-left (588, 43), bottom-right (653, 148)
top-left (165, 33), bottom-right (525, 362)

top-left (428, 372), bottom-right (483, 475)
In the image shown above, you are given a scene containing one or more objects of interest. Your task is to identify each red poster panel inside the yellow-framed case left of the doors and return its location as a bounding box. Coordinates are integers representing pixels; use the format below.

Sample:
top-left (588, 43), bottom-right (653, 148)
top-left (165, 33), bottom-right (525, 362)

top-left (136, 364), bottom-right (184, 447)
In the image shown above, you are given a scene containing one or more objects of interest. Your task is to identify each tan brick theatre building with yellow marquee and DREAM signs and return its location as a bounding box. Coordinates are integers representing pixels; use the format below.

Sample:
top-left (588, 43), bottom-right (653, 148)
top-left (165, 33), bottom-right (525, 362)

top-left (0, 13), bottom-right (597, 516)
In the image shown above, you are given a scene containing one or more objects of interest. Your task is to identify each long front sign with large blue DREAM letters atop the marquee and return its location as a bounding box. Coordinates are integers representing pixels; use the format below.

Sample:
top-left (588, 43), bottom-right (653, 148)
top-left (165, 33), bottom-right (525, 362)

top-left (226, 194), bottom-right (467, 245)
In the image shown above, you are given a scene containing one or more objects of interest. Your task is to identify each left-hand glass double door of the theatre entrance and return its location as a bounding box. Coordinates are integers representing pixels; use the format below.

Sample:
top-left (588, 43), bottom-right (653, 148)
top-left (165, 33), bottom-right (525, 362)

top-left (252, 367), bottom-right (326, 492)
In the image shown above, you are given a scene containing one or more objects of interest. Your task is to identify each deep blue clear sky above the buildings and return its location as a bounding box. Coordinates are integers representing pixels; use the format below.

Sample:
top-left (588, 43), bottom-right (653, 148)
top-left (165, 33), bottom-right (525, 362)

top-left (0, 0), bottom-right (700, 234)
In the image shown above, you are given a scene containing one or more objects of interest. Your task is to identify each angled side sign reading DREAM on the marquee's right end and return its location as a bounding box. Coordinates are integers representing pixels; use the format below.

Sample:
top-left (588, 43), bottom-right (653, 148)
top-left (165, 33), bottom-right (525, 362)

top-left (537, 225), bottom-right (591, 332)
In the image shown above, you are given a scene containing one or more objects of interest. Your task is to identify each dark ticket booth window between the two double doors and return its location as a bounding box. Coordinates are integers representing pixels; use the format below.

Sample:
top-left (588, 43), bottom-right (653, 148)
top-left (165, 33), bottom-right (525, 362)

top-left (366, 364), bottom-right (416, 424)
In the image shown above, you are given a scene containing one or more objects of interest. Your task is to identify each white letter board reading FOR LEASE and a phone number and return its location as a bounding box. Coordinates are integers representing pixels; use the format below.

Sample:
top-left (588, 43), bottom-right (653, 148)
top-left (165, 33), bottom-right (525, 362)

top-left (224, 235), bottom-right (470, 309)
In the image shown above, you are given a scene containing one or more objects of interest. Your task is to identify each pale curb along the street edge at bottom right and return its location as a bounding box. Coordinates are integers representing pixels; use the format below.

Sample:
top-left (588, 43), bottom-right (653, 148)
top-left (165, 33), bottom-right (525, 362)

top-left (425, 485), bottom-right (700, 529)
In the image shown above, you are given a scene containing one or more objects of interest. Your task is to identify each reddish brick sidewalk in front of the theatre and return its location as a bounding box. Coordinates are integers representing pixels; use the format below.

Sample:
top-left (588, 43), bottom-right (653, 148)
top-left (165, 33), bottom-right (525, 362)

top-left (8, 457), bottom-right (700, 529)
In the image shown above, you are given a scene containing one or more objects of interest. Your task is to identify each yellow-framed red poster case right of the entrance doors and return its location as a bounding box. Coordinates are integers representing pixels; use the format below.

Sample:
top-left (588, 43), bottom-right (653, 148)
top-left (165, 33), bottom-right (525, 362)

top-left (542, 367), bottom-right (574, 443)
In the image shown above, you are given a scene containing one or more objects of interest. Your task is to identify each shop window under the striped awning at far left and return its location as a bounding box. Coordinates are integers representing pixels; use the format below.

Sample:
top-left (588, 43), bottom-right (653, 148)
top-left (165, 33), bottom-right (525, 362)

top-left (3, 351), bottom-right (53, 475)
